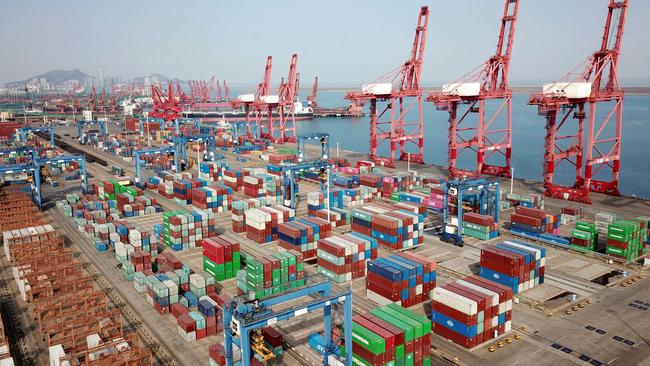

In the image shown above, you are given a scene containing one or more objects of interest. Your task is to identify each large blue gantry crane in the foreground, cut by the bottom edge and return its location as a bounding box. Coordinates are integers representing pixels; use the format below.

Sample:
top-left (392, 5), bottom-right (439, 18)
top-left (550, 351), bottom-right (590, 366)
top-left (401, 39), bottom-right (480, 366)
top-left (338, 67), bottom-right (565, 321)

top-left (223, 275), bottom-right (352, 366)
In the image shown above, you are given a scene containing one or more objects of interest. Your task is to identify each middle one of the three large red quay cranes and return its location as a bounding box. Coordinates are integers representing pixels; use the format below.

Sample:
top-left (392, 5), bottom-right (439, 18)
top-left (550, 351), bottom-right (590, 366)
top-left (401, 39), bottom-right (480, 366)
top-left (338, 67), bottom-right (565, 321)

top-left (427, 0), bottom-right (519, 178)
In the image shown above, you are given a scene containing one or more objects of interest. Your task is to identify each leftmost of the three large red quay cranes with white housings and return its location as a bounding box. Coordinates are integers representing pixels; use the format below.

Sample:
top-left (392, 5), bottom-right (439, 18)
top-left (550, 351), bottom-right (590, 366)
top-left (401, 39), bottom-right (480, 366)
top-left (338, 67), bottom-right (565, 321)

top-left (345, 6), bottom-right (429, 167)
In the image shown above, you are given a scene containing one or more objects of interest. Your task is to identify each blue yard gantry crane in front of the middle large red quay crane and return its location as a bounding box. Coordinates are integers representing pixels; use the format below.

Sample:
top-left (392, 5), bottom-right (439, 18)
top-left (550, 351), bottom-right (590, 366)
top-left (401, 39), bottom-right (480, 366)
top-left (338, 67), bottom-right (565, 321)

top-left (440, 179), bottom-right (500, 246)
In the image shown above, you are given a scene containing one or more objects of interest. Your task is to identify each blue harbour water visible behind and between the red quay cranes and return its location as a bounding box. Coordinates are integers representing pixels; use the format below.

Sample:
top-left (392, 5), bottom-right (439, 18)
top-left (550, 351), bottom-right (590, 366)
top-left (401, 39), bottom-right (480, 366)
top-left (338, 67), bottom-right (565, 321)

top-left (296, 92), bottom-right (650, 198)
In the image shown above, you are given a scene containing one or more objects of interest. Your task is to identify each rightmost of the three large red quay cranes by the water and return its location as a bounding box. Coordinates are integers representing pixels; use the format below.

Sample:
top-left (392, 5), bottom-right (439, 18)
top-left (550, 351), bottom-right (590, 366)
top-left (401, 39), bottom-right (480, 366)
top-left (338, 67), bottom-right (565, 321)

top-left (529, 0), bottom-right (628, 203)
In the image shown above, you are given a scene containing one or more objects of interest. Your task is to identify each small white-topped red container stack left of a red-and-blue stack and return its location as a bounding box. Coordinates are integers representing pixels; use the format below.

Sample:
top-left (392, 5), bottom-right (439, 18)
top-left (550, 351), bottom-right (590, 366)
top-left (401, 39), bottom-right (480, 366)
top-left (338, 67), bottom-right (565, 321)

top-left (246, 205), bottom-right (295, 244)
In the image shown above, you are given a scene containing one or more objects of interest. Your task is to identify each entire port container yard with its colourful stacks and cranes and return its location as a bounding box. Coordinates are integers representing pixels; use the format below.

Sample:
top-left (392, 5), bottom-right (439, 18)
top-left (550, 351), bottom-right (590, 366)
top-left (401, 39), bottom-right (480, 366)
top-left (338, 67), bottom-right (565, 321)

top-left (0, 0), bottom-right (650, 366)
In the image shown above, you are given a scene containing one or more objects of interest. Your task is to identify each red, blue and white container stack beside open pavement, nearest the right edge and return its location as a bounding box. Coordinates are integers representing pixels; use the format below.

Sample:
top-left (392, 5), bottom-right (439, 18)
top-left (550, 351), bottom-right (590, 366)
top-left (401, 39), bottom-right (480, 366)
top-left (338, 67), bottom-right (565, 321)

top-left (480, 240), bottom-right (546, 294)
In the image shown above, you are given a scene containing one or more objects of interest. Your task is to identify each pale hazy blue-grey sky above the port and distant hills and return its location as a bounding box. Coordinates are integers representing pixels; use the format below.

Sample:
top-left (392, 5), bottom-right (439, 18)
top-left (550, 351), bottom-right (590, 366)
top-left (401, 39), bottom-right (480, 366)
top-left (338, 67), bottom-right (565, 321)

top-left (0, 0), bottom-right (650, 85)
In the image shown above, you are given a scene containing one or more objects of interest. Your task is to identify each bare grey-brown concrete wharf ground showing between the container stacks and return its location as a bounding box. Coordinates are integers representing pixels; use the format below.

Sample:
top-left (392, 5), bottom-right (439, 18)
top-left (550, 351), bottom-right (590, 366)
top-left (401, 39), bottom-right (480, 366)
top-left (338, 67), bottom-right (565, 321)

top-left (22, 123), bottom-right (650, 366)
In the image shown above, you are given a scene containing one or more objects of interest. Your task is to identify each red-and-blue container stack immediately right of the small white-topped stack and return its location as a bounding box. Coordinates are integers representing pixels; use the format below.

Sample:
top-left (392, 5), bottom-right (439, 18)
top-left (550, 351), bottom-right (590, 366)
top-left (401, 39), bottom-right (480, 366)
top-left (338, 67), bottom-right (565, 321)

top-left (278, 217), bottom-right (332, 259)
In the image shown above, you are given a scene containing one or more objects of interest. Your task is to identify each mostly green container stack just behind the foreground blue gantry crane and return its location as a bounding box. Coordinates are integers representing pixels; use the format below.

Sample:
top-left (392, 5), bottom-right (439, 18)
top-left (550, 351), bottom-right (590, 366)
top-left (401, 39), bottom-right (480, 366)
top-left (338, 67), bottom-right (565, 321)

top-left (237, 250), bottom-right (305, 300)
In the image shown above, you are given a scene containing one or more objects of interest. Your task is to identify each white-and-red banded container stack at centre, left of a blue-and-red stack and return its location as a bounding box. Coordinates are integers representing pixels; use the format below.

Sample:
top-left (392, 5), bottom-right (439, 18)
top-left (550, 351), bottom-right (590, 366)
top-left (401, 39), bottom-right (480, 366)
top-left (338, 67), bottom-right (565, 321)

top-left (316, 233), bottom-right (377, 283)
